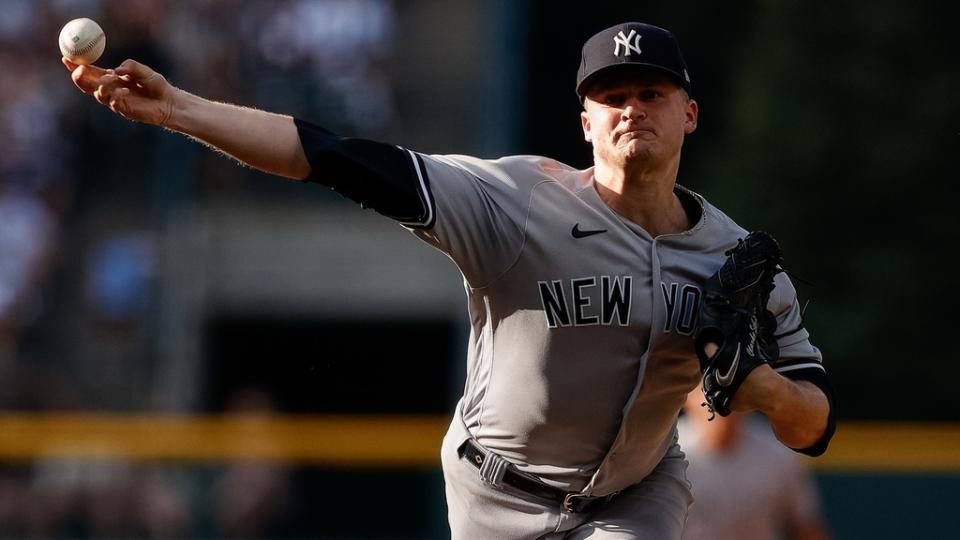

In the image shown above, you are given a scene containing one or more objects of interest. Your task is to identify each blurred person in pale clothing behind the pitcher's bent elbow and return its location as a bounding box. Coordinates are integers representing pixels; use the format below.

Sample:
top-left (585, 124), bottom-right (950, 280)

top-left (680, 388), bottom-right (828, 540)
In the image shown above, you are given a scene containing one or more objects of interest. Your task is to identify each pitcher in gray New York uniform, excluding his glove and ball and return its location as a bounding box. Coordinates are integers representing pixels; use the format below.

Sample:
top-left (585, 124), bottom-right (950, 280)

top-left (65, 23), bottom-right (833, 539)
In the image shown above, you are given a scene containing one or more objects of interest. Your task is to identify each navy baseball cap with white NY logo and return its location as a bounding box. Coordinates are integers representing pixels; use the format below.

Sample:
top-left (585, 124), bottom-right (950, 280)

top-left (577, 22), bottom-right (690, 101)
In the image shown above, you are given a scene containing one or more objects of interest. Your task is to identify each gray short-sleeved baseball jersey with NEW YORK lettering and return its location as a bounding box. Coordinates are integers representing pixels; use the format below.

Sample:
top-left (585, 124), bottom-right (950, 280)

top-left (405, 152), bottom-right (823, 495)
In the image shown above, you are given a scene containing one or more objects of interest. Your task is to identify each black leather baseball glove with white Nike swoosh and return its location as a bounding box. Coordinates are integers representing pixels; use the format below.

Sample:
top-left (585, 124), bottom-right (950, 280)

top-left (694, 231), bottom-right (783, 420)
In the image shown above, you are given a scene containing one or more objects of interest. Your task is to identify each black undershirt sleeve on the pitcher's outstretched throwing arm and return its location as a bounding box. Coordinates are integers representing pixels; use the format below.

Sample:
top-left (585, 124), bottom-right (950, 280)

top-left (294, 118), bottom-right (431, 227)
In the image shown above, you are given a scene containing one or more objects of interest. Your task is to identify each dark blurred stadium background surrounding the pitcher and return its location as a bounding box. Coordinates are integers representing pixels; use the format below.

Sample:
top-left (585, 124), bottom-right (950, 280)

top-left (0, 0), bottom-right (960, 539)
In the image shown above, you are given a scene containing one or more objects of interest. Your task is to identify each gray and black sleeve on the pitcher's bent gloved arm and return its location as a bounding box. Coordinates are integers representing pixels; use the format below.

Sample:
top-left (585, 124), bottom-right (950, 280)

top-left (767, 272), bottom-right (836, 456)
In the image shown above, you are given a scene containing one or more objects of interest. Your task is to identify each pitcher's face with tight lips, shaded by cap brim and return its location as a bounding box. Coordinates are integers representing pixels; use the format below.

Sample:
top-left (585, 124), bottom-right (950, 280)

top-left (580, 72), bottom-right (697, 168)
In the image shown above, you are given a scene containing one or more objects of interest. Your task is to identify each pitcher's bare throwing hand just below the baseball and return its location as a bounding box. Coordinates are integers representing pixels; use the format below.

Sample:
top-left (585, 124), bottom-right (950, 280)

top-left (63, 58), bottom-right (177, 126)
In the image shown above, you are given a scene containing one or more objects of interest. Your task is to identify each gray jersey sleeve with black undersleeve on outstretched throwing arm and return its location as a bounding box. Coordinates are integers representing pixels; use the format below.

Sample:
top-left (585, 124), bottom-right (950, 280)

top-left (294, 118), bottom-right (536, 287)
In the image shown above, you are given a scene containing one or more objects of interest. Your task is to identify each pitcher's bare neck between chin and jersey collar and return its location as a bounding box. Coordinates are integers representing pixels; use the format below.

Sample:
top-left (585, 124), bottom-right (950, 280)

top-left (594, 161), bottom-right (691, 236)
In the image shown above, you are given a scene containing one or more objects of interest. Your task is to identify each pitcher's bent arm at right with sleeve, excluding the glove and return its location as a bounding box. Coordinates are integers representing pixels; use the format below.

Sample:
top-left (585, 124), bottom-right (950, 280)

top-left (731, 273), bottom-right (836, 456)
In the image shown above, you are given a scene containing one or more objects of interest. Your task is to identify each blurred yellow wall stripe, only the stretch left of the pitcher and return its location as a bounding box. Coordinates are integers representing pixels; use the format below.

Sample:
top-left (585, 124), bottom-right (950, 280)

top-left (0, 413), bottom-right (450, 467)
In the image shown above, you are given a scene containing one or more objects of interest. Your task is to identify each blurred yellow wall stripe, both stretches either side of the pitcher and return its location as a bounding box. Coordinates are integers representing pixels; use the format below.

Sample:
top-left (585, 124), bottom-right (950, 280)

top-left (0, 413), bottom-right (960, 473)
